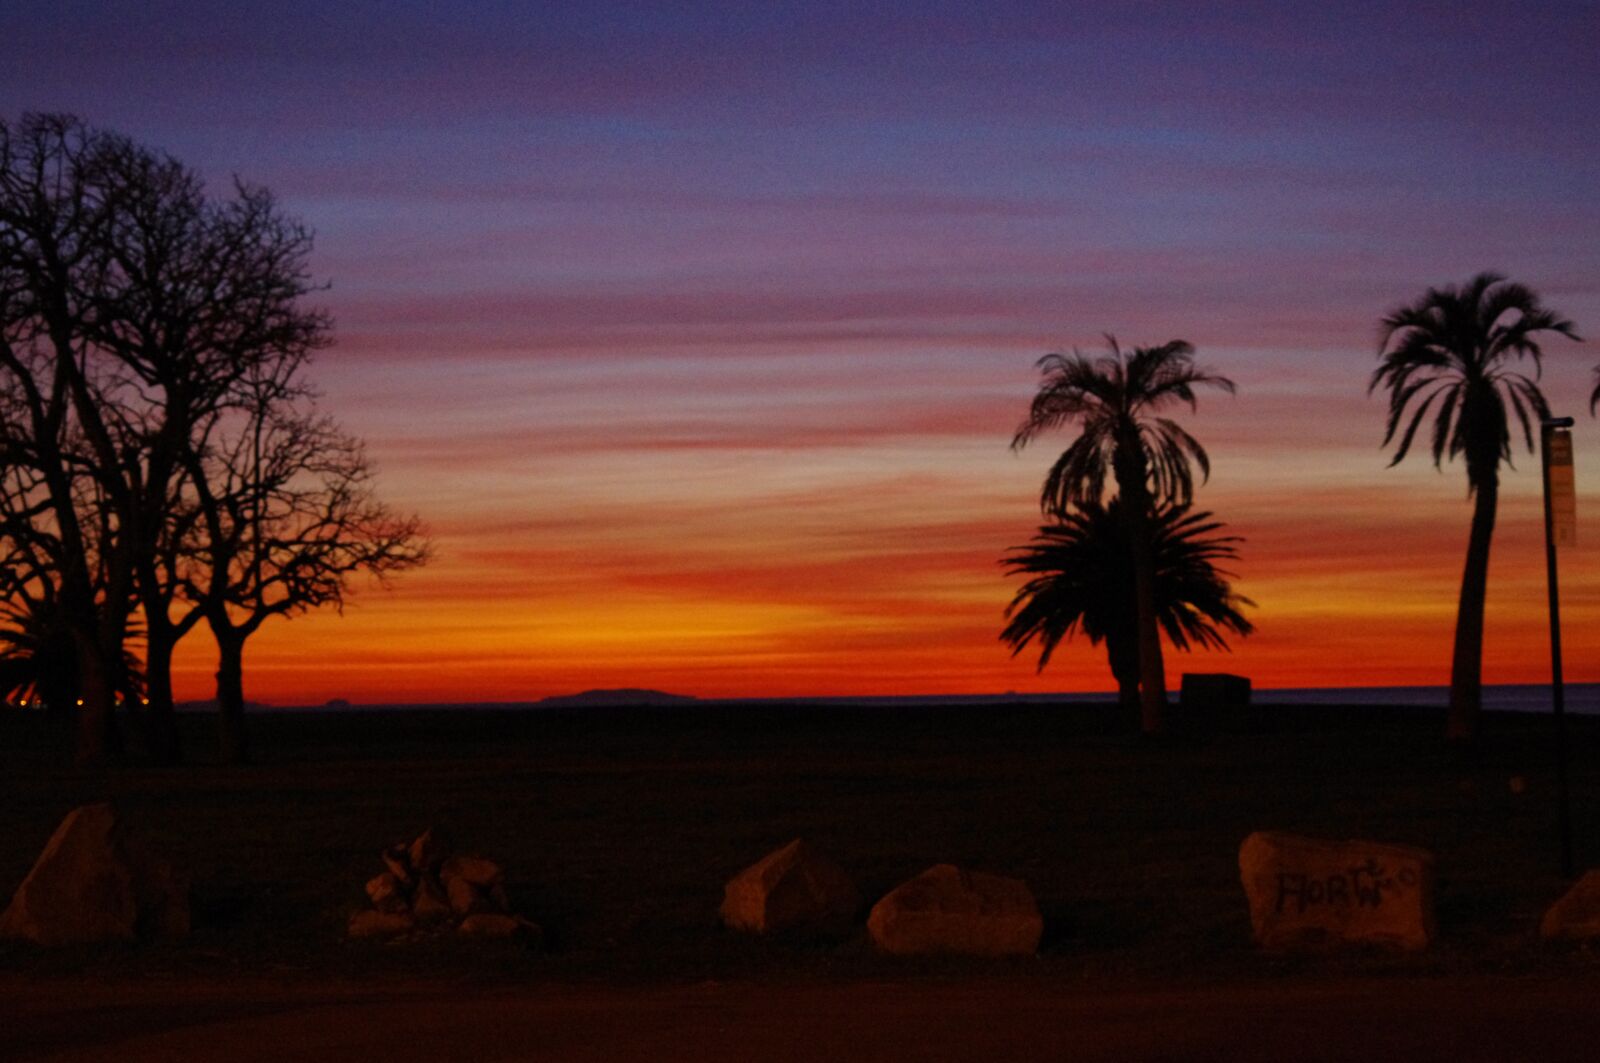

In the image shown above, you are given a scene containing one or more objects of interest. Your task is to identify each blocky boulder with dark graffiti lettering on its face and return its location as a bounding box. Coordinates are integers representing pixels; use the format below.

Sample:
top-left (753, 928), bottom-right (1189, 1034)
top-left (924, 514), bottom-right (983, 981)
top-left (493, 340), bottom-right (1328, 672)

top-left (1238, 831), bottom-right (1434, 951)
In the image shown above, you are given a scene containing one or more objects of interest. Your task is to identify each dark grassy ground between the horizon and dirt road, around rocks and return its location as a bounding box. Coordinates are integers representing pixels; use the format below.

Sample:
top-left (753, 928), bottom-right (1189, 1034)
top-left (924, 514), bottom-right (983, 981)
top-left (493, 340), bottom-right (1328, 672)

top-left (0, 706), bottom-right (1600, 983)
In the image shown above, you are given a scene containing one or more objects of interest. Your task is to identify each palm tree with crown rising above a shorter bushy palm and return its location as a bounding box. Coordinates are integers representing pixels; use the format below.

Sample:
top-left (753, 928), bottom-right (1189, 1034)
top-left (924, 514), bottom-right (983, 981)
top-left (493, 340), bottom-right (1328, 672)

top-left (1011, 336), bottom-right (1234, 733)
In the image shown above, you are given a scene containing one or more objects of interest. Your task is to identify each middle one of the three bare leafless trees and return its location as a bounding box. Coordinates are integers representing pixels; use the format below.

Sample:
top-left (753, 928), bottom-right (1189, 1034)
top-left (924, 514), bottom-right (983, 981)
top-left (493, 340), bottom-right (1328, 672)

top-left (88, 141), bottom-right (328, 762)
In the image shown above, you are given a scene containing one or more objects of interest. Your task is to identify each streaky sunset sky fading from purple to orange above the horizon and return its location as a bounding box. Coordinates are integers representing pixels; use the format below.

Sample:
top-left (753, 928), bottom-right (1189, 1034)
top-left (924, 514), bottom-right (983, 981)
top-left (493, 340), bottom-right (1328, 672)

top-left (0, 0), bottom-right (1600, 703)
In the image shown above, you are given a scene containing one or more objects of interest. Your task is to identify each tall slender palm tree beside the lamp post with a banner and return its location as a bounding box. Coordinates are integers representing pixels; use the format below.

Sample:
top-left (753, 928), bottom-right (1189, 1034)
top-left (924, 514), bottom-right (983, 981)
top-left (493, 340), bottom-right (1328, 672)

top-left (1366, 274), bottom-right (1578, 741)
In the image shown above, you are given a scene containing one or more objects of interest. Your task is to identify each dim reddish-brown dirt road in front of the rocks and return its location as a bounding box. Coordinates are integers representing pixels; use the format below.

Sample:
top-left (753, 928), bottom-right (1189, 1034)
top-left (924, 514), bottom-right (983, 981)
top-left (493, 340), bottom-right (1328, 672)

top-left (0, 980), bottom-right (1600, 1063)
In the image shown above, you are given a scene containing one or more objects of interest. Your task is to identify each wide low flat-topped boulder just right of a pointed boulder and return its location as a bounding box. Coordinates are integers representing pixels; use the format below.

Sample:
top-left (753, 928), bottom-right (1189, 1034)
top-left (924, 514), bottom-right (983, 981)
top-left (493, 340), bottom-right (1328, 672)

top-left (867, 864), bottom-right (1045, 956)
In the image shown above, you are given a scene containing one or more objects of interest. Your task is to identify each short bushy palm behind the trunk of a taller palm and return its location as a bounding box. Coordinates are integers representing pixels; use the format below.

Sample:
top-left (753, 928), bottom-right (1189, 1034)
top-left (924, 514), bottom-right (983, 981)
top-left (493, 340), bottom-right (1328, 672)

top-left (1000, 498), bottom-right (1254, 714)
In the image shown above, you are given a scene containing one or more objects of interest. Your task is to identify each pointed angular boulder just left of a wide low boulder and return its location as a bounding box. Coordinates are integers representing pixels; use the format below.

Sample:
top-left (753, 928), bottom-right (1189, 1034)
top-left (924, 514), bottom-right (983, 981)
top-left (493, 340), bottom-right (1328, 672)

top-left (722, 839), bottom-right (861, 933)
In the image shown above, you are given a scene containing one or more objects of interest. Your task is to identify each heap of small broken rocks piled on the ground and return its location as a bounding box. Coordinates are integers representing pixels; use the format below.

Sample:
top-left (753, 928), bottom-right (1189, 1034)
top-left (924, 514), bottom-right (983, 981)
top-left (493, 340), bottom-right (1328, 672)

top-left (347, 829), bottom-right (541, 940)
